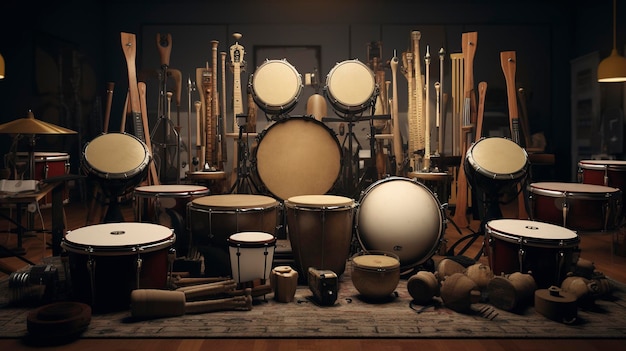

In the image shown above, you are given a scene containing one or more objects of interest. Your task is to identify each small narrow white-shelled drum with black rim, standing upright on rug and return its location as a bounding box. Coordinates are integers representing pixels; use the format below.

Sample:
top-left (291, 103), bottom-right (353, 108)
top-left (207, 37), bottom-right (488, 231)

top-left (228, 232), bottom-right (276, 289)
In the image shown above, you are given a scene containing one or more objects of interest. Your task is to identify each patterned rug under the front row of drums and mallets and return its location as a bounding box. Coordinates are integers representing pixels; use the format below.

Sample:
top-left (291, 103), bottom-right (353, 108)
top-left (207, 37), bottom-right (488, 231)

top-left (0, 262), bottom-right (626, 339)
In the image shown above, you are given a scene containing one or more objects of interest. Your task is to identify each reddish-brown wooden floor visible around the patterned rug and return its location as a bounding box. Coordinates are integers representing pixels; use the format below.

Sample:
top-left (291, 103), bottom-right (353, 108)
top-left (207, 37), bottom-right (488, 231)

top-left (0, 198), bottom-right (626, 351)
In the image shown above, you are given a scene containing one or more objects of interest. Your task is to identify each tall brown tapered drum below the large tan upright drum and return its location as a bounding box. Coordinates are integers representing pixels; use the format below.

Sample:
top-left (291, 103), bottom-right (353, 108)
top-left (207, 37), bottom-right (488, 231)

top-left (285, 195), bottom-right (355, 277)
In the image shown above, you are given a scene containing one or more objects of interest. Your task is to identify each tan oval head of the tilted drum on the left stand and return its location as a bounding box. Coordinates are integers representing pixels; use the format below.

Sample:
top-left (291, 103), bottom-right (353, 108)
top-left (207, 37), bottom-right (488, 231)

top-left (83, 133), bottom-right (150, 179)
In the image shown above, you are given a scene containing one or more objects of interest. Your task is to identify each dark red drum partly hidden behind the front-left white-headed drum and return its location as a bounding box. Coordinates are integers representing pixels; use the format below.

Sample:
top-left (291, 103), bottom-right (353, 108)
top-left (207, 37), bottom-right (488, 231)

top-left (134, 184), bottom-right (210, 256)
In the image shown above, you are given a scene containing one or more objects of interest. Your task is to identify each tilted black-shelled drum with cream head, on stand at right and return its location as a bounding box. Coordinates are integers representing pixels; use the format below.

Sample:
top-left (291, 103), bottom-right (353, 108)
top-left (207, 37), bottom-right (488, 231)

top-left (464, 137), bottom-right (529, 191)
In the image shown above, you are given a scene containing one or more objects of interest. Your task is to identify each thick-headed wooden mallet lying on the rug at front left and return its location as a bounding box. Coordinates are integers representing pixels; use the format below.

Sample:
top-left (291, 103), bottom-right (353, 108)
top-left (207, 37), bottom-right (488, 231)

top-left (130, 289), bottom-right (252, 319)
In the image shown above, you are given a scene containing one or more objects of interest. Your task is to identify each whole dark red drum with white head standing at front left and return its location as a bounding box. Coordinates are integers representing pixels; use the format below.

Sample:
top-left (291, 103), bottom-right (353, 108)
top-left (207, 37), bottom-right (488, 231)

top-left (61, 222), bottom-right (176, 312)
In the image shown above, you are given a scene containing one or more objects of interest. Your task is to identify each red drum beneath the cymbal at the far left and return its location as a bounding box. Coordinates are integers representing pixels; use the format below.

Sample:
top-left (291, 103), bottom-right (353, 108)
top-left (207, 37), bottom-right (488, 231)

top-left (16, 152), bottom-right (70, 208)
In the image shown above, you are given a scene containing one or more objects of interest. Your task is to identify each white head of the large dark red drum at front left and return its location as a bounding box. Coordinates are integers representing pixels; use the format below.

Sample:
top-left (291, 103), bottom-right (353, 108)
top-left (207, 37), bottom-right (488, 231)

top-left (61, 222), bottom-right (175, 255)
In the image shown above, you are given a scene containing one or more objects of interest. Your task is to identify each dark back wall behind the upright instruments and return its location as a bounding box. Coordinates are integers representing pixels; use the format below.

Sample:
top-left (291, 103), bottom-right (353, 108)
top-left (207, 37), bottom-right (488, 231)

top-left (0, 0), bottom-right (626, 181)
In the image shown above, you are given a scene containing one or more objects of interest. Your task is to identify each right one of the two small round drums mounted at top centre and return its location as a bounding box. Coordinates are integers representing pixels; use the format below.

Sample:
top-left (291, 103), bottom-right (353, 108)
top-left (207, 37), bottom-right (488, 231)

top-left (324, 59), bottom-right (378, 114)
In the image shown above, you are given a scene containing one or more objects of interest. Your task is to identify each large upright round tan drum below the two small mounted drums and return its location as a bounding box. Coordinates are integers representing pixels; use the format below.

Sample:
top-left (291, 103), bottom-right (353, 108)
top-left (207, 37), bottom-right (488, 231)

top-left (254, 117), bottom-right (341, 200)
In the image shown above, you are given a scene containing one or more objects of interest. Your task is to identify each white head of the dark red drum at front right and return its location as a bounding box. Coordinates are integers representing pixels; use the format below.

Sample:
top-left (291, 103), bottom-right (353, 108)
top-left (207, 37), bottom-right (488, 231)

top-left (485, 219), bottom-right (580, 247)
